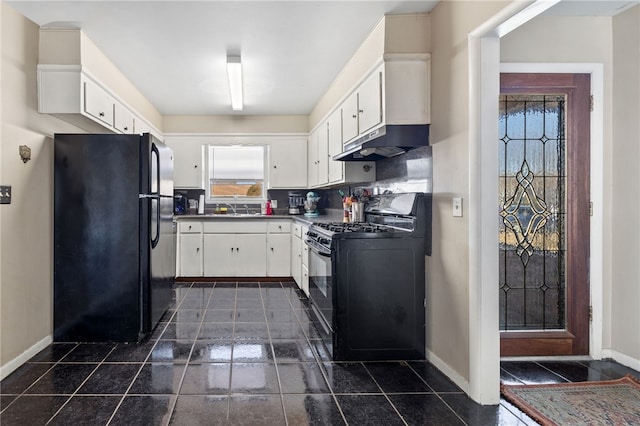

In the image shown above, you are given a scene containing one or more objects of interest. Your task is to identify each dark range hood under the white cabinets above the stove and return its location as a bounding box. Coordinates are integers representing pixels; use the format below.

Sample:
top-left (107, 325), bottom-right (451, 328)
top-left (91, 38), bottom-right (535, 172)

top-left (333, 124), bottom-right (429, 161)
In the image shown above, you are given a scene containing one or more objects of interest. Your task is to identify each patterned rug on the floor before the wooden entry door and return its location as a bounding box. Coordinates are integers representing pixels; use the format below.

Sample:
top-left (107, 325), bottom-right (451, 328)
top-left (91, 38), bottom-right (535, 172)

top-left (500, 376), bottom-right (640, 426)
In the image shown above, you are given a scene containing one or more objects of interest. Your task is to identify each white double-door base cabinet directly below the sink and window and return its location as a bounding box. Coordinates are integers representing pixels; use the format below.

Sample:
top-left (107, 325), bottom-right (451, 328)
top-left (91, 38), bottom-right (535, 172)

top-left (203, 234), bottom-right (267, 277)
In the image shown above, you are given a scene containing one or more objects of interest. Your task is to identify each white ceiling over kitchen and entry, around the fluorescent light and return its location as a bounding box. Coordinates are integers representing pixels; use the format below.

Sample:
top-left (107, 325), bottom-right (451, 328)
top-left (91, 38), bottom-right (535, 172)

top-left (5, 0), bottom-right (637, 115)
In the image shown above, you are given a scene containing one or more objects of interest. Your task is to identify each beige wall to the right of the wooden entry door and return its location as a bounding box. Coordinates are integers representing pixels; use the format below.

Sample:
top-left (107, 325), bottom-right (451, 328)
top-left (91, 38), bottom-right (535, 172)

top-left (608, 6), bottom-right (640, 368)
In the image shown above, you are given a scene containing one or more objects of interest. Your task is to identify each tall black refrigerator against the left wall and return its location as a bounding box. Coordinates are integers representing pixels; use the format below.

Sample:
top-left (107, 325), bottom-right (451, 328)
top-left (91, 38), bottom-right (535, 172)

top-left (53, 133), bottom-right (176, 342)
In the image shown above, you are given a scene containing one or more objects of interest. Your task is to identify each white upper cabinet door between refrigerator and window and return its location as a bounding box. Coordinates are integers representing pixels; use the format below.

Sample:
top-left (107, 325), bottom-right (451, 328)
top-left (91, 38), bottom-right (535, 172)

top-left (165, 138), bottom-right (204, 188)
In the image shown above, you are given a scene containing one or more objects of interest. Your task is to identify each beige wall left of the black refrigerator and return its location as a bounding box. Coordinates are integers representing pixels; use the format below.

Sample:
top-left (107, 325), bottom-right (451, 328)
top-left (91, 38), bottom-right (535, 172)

top-left (0, 3), bottom-right (88, 377)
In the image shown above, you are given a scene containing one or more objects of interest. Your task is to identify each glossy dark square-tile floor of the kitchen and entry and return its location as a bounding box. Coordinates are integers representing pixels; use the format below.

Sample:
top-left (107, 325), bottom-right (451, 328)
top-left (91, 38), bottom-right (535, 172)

top-left (0, 282), bottom-right (638, 426)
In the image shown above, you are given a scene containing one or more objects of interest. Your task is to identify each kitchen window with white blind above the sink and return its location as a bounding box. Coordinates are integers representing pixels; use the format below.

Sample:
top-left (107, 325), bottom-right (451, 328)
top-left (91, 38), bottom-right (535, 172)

top-left (207, 145), bottom-right (266, 202)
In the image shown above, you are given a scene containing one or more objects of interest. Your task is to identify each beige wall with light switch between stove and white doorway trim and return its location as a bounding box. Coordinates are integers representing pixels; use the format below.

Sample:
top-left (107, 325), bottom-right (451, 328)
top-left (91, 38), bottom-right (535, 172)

top-left (427, 1), bottom-right (510, 392)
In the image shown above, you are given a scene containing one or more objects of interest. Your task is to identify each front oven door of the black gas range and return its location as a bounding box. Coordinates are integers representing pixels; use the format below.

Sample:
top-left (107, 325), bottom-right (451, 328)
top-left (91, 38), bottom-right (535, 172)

top-left (308, 241), bottom-right (334, 352)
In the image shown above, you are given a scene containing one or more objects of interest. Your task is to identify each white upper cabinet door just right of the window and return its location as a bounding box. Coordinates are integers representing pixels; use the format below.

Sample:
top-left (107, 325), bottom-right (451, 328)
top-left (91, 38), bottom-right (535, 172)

top-left (269, 139), bottom-right (307, 189)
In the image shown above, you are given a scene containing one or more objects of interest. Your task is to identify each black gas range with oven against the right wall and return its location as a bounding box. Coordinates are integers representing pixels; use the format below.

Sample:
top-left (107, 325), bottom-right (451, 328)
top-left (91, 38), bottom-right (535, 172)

top-left (306, 193), bottom-right (431, 360)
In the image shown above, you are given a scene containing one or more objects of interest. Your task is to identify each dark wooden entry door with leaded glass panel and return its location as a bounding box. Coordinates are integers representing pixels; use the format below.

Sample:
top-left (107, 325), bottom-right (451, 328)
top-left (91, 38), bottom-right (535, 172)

top-left (498, 74), bottom-right (591, 356)
